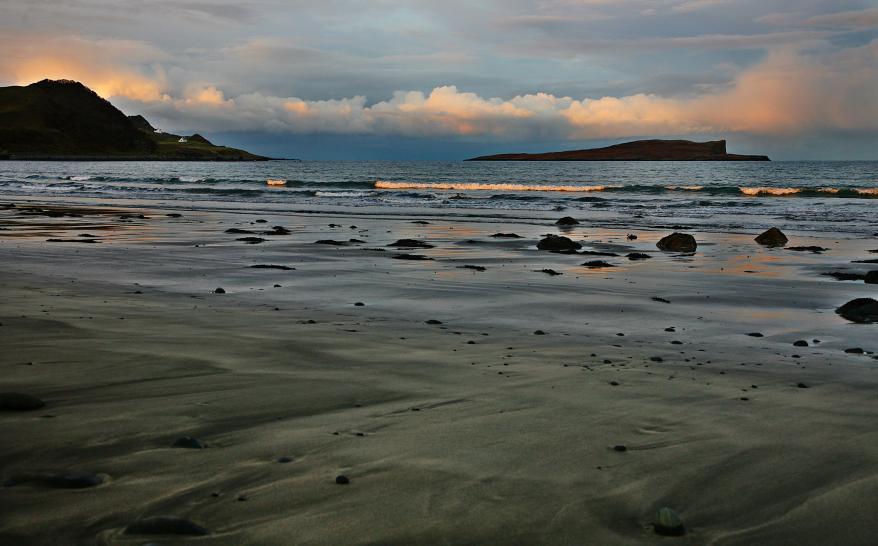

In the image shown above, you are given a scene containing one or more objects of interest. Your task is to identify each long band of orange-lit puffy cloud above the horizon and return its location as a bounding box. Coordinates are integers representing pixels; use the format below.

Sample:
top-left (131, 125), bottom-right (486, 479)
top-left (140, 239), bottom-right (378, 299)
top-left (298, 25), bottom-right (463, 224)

top-left (0, 28), bottom-right (878, 140)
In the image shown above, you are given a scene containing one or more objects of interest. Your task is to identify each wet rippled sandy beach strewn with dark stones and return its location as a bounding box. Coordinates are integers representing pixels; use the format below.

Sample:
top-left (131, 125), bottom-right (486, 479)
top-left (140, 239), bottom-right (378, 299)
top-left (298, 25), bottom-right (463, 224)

top-left (0, 204), bottom-right (878, 545)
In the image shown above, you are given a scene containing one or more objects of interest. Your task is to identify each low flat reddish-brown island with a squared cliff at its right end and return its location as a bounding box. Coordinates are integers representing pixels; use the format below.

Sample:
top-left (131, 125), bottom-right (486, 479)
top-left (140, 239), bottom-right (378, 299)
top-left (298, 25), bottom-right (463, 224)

top-left (467, 140), bottom-right (771, 161)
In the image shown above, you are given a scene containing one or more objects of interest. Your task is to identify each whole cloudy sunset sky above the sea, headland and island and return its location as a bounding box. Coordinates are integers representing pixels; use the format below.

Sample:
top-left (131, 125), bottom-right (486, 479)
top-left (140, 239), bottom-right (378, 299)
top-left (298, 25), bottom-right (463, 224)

top-left (0, 0), bottom-right (878, 160)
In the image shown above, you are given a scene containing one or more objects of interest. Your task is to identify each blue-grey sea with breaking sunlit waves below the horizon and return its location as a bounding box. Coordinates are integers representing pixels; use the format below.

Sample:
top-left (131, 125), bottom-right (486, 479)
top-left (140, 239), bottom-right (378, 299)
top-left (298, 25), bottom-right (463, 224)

top-left (0, 161), bottom-right (878, 235)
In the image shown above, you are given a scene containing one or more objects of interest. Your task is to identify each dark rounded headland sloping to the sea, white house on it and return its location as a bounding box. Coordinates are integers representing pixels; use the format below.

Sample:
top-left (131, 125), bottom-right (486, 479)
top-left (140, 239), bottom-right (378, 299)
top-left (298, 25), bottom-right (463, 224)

top-left (0, 80), bottom-right (269, 161)
